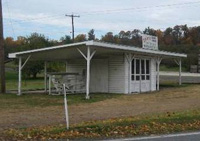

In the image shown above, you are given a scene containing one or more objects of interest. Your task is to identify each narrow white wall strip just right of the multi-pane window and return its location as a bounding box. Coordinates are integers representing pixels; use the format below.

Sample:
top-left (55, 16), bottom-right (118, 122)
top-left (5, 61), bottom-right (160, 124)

top-left (151, 58), bottom-right (157, 91)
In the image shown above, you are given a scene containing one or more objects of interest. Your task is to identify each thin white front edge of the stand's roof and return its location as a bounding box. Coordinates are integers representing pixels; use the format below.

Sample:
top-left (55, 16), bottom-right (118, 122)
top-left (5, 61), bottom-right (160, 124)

top-left (9, 41), bottom-right (187, 58)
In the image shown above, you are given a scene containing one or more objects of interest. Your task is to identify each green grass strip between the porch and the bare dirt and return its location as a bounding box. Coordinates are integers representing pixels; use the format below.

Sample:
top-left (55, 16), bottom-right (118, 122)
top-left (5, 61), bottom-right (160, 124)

top-left (0, 94), bottom-right (121, 109)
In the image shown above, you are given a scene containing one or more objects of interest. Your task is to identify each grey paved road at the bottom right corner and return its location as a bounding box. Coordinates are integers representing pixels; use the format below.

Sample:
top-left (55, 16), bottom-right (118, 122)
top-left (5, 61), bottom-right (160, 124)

top-left (107, 132), bottom-right (200, 141)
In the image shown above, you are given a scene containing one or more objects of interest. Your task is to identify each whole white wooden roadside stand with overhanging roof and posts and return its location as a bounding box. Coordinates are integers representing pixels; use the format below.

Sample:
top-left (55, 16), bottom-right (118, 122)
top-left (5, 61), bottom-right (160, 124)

top-left (9, 41), bottom-right (187, 99)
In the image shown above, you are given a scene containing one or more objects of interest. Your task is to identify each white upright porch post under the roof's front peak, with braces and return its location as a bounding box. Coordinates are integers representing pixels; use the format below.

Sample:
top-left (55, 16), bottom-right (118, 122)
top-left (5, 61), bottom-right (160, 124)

top-left (86, 46), bottom-right (90, 99)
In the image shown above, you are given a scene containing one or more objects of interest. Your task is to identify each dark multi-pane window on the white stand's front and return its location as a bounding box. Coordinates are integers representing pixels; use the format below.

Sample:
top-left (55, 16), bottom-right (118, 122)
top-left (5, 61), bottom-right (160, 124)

top-left (131, 59), bottom-right (150, 81)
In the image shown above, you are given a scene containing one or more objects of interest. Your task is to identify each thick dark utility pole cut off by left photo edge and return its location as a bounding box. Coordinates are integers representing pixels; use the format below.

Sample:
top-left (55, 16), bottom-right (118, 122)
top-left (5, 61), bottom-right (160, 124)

top-left (0, 0), bottom-right (6, 93)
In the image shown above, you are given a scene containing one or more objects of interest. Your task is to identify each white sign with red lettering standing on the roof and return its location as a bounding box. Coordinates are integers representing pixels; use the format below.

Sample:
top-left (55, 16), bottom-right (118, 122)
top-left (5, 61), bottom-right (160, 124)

top-left (142, 34), bottom-right (158, 50)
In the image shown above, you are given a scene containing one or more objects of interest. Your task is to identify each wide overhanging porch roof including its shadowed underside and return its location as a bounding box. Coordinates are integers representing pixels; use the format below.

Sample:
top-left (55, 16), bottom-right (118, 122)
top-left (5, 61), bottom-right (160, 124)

top-left (9, 41), bottom-right (187, 61)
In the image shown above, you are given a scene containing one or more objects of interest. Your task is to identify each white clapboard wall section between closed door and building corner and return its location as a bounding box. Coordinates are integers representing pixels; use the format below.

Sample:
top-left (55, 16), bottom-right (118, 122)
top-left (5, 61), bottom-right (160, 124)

top-left (108, 54), bottom-right (125, 93)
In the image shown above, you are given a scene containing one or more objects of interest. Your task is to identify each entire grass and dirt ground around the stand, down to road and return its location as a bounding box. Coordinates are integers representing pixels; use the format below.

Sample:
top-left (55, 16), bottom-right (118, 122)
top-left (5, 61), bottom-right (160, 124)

top-left (0, 68), bottom-right (200, 140)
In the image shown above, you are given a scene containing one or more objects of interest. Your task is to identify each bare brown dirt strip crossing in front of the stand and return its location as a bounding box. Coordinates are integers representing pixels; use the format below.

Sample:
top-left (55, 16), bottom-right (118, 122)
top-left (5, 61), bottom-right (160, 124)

top-left (0, 85), bottom-right (200, 129)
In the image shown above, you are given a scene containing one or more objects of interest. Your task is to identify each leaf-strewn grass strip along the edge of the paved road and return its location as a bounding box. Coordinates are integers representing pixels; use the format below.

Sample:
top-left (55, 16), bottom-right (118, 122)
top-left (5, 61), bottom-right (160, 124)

top-left (4, 110), bottom-right (200, 140)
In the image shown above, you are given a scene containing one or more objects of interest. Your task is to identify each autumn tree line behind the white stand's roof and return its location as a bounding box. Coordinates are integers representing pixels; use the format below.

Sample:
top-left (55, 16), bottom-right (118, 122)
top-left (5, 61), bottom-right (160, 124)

top-left (4, 25), bottom-right (200, 77)
